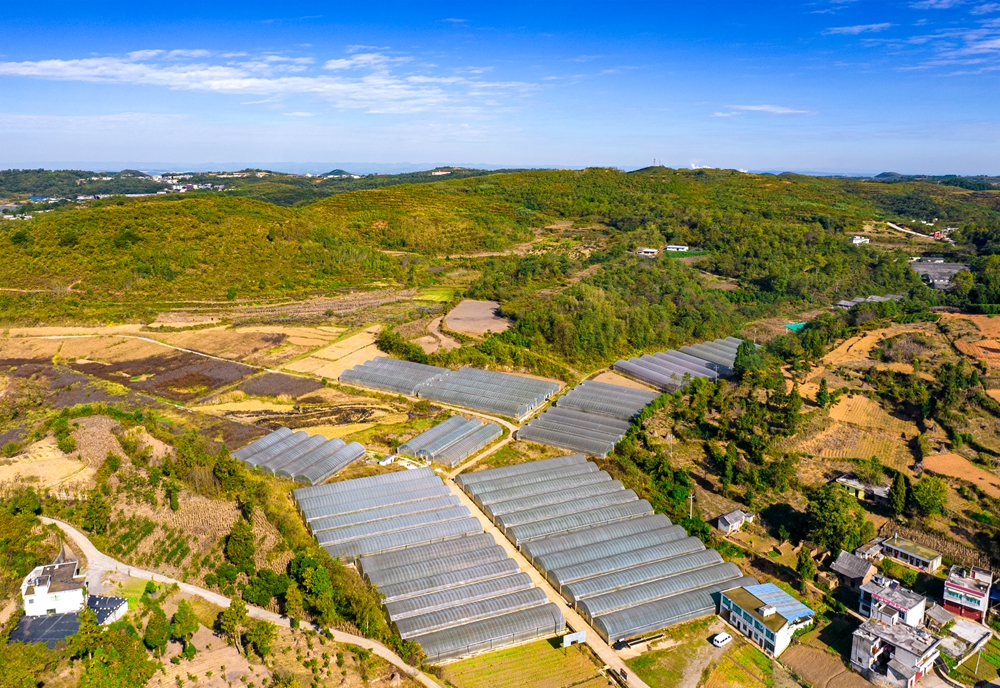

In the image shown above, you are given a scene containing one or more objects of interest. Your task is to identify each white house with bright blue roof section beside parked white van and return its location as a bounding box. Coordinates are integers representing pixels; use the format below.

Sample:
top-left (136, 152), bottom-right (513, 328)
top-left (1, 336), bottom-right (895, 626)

top-left (719, 583), bottom-right (816, 657)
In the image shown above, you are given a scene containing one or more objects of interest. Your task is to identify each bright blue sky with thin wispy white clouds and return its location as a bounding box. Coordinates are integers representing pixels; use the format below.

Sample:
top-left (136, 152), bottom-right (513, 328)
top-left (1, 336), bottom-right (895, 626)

top-left (0, 0), bottom-right (1000, 174)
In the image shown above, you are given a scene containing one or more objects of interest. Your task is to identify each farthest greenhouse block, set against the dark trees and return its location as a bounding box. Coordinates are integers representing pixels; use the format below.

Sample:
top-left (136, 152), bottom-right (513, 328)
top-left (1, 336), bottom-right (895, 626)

top-left (614, 337), bottom-right (744, 392)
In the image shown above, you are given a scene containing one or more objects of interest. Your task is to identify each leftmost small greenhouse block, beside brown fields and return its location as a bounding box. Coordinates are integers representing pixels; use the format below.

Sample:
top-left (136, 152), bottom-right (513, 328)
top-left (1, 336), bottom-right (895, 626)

top-left (233, 428), bottom-right (365, 485)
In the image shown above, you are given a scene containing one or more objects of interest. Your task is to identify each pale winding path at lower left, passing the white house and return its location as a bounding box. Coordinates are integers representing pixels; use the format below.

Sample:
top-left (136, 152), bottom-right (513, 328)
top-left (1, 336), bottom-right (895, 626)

top-left (40, 516), bottom-right (440, 688)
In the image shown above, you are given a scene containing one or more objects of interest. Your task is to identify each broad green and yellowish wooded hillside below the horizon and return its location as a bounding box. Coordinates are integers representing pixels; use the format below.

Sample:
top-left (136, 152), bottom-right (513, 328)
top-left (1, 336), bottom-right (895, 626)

top-left (0, 168), bottom-right (1000, 326)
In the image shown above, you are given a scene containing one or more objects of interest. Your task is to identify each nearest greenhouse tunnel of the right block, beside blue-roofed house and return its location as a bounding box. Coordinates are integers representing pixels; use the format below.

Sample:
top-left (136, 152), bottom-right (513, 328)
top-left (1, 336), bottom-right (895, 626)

top-left (593, 577), bottom-right (757, 643)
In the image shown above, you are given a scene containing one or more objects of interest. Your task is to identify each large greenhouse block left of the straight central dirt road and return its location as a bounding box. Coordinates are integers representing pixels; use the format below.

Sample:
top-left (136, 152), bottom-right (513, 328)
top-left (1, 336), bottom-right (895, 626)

top-left (293, 468), bottom-right (566, 663)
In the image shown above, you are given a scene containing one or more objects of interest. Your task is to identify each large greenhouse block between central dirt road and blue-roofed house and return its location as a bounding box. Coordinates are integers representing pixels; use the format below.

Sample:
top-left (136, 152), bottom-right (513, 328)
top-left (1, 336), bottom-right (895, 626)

top-left (456, 454), bottom-right (756, 642)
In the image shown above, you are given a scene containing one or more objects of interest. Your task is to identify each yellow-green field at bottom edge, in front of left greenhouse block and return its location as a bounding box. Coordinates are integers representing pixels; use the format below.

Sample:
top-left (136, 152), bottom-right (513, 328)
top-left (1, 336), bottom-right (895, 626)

top-left (442, 639), bottom-right (608, 688)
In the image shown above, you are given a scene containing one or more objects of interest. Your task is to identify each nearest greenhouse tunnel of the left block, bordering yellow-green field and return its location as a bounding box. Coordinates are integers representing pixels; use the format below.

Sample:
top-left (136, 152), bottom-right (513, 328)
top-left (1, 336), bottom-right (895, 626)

top-left (412, 604), bottom-right (566, 662)
